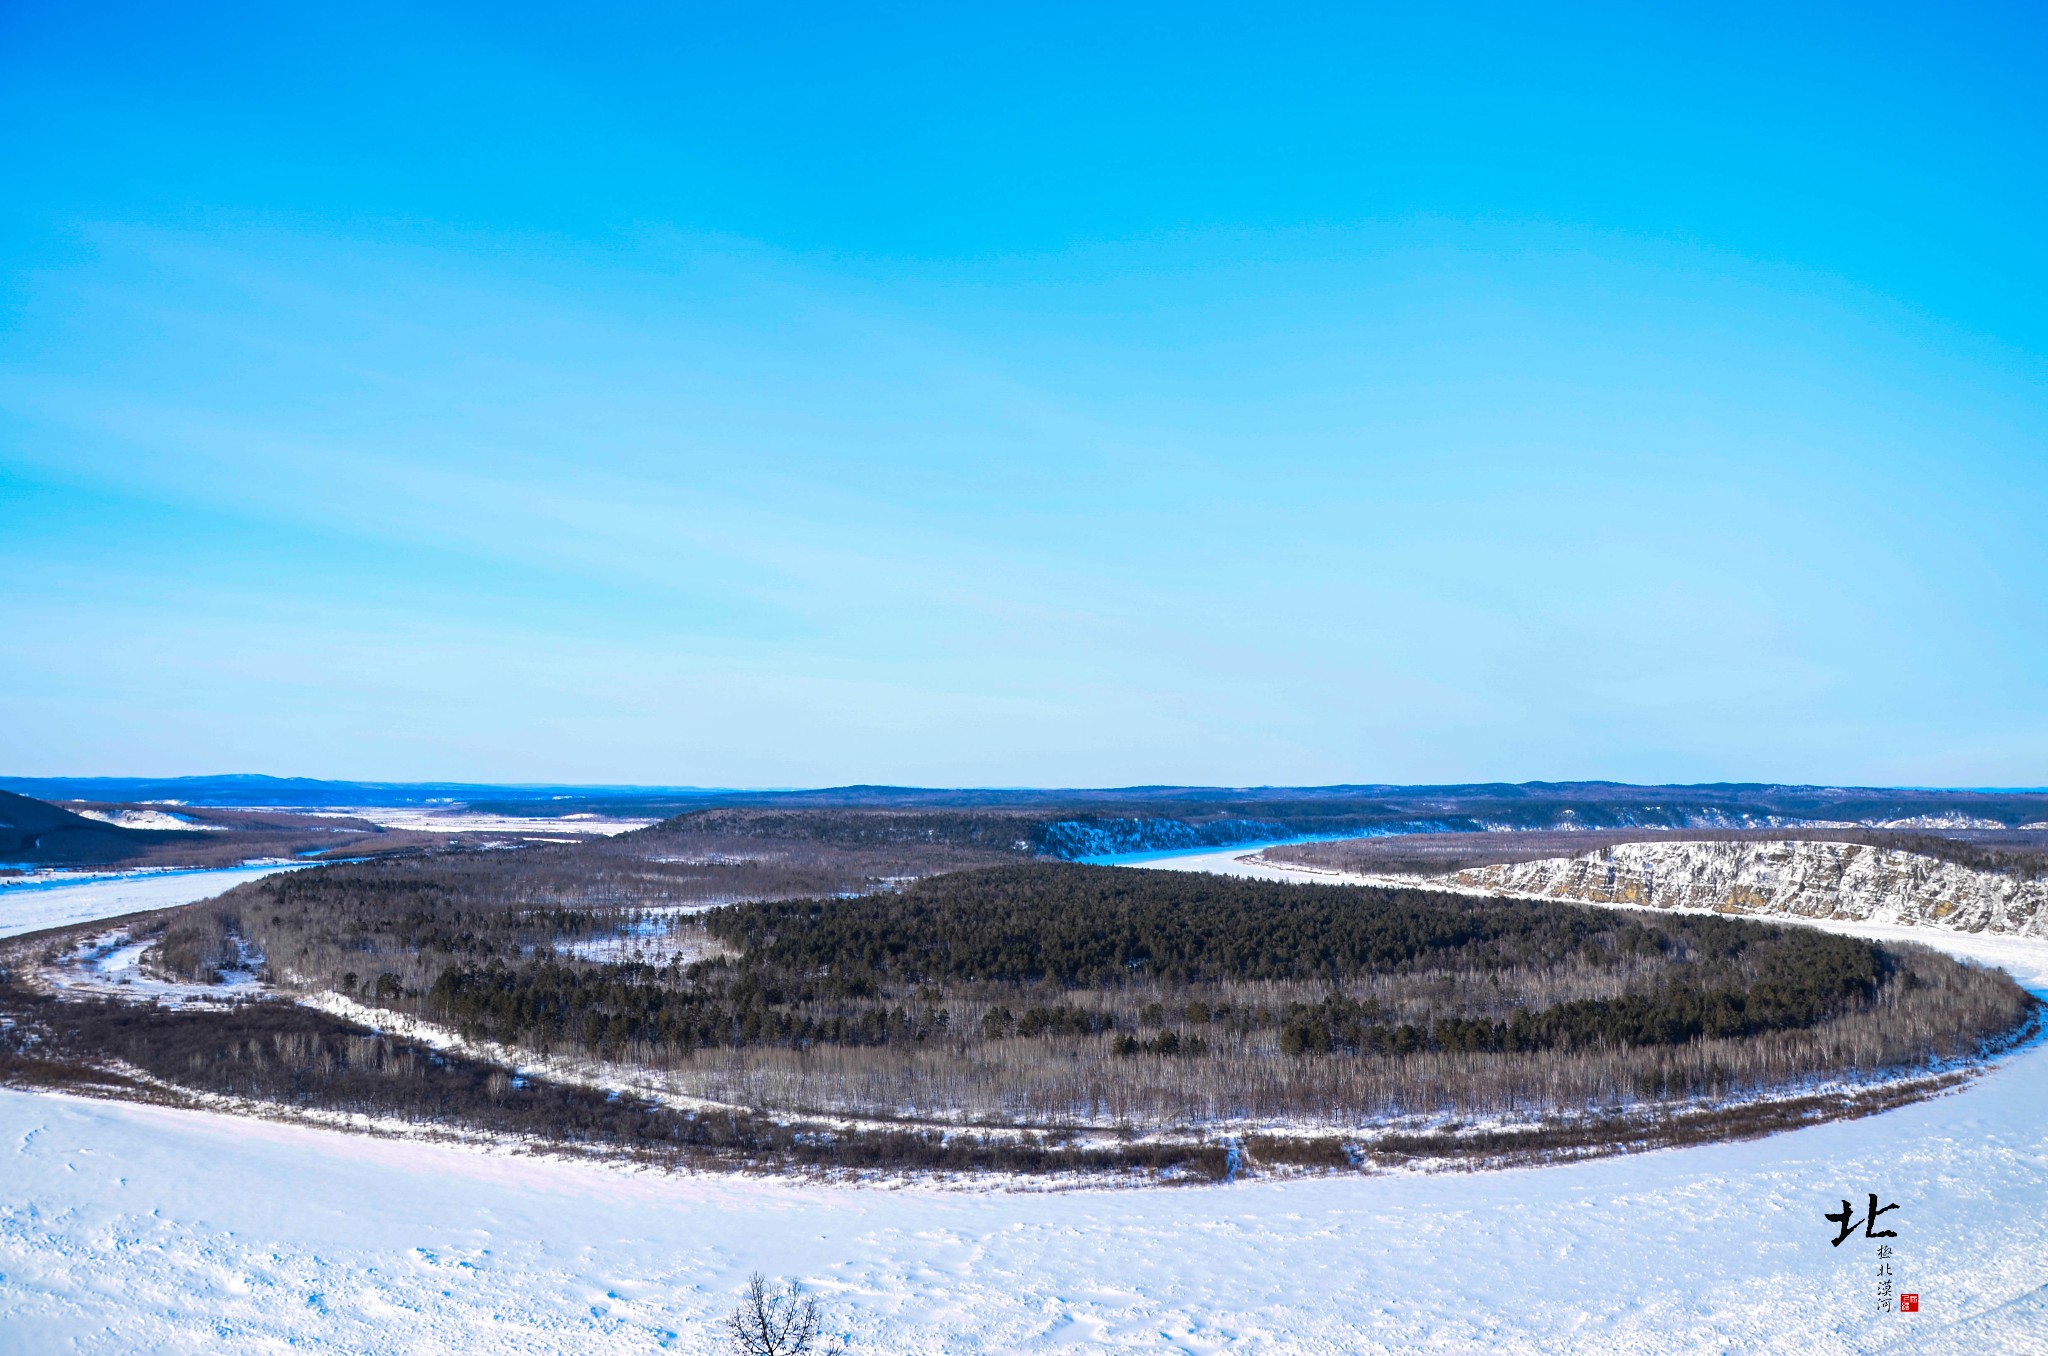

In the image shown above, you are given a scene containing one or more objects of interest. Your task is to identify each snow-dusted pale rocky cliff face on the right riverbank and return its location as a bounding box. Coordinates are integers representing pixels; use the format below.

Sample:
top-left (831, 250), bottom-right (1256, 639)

top-left (1448, 842), bottom-right (2048, 938)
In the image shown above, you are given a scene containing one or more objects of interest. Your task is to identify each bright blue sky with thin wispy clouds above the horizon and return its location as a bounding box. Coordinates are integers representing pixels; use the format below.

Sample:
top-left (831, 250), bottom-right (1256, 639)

top-left (0, 4), bottom-right (2048, 785)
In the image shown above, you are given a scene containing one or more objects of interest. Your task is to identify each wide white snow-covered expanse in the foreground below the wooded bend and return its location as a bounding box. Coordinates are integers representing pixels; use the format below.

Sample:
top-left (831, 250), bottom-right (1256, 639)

top-left (0, 848), bottom-right (2048, 1354)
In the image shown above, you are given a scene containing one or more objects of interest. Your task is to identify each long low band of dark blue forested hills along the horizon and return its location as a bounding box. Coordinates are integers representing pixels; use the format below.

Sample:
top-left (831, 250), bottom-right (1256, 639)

top-left (0, 776), bottom-right (2048, 858)
